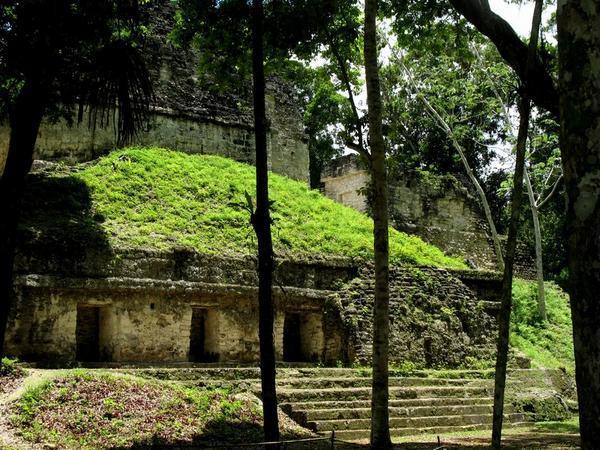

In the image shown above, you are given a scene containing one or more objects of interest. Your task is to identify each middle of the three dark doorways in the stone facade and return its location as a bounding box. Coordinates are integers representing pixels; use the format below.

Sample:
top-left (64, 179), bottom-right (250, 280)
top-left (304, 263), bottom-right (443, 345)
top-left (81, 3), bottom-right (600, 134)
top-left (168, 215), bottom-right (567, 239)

top-left (189, 308), bottom-right (219, 362)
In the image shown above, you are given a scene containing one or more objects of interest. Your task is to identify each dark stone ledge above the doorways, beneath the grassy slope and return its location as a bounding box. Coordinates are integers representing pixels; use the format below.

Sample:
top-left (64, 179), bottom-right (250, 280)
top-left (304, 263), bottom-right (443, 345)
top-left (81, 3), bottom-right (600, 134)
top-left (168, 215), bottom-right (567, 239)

top-left (15, 246), bottom-right (362, 290)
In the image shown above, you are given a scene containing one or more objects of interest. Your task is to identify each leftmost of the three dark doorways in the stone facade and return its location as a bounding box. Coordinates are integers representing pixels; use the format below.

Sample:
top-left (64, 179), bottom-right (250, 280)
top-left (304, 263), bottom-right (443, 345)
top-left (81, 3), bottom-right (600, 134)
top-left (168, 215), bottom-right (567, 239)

top-left (75, 306), bottom-right (102, 362)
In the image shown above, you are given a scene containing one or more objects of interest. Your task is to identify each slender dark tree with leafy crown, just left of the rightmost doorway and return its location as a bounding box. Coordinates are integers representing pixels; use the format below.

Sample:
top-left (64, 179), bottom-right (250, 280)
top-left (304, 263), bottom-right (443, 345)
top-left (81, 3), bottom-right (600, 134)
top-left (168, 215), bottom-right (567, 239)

top-left (175, 0), bottom-right (354, 441)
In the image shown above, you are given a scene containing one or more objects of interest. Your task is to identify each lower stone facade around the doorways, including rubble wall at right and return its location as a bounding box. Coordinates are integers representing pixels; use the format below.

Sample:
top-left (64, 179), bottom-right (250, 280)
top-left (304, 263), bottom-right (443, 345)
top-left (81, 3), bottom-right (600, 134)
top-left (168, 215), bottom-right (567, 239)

top-left (6, 240), bottom-right (506, 367)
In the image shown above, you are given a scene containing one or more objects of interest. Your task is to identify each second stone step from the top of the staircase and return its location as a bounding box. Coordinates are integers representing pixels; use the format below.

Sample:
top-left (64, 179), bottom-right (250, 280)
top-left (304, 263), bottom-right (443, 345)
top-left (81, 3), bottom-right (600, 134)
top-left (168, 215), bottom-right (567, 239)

top-left (277, 377), bottom-right (494, 389)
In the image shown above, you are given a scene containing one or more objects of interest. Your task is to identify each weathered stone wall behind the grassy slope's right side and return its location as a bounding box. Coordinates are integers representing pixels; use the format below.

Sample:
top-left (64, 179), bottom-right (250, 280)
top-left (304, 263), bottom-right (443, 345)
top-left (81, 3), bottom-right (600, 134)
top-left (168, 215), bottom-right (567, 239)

top-left (322, 155), bottom-right (496, 270)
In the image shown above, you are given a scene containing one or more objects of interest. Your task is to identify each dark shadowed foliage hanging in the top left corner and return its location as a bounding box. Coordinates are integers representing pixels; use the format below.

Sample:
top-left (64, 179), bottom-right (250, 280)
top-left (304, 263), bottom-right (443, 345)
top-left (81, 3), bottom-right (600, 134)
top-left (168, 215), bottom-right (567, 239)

top-left (0, 0), bottom-right (152, 141)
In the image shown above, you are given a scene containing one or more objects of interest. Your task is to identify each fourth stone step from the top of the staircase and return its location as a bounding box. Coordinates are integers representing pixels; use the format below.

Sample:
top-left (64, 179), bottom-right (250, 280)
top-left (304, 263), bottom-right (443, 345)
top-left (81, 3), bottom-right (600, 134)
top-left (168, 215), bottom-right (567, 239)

top-left (279, 397), bottom-right (494, 411)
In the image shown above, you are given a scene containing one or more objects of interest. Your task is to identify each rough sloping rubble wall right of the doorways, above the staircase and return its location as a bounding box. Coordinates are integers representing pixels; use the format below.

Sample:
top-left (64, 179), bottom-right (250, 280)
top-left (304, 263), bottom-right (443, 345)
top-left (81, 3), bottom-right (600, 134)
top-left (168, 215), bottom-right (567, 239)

top-left (332, 267), bottom-right (496, 368)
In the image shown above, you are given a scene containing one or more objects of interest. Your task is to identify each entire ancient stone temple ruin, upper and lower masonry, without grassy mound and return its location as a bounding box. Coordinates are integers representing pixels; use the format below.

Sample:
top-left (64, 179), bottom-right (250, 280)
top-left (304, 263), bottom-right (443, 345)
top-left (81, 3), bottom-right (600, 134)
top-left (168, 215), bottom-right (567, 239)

top-left (0, 1), bottom-right (506, 367)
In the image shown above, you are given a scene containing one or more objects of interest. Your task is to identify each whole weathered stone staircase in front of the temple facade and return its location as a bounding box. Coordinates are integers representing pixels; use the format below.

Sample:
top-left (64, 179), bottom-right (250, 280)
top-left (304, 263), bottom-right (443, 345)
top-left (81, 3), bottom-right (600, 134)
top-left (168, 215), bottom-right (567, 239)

top-left (117, 367), bottom-right (548, 441)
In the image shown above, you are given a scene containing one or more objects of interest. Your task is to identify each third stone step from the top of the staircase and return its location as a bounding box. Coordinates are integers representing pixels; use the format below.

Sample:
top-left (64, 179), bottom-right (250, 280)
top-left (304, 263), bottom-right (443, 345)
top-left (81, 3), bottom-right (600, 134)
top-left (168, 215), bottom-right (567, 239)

top-left (274, 386), bottom-right (492, 403)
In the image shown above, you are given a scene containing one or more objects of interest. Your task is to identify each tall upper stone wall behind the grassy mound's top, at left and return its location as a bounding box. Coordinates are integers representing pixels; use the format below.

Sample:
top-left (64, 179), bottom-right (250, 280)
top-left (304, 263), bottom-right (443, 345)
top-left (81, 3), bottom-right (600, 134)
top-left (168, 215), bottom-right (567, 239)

top-left (0, 0), bottom-right (308, 182)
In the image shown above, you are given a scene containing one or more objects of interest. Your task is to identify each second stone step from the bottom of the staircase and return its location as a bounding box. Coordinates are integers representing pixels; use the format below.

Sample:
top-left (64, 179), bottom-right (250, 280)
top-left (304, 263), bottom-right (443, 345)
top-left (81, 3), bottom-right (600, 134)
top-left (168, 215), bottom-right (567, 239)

top-left (306, 413), bottom-right (527, 434)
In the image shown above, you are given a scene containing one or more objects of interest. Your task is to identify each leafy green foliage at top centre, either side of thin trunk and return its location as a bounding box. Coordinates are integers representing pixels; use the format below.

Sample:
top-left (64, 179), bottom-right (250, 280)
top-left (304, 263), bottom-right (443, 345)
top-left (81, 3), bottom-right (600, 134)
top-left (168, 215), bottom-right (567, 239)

top-left (172, 0), bottom-right (359, 93)
